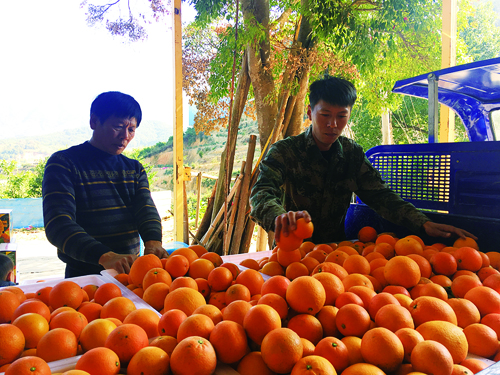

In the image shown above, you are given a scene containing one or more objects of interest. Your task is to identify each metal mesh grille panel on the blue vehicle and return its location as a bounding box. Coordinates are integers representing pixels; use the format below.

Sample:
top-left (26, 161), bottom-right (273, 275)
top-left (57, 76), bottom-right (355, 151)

top-left (370, 154), bottom-right (451, 202)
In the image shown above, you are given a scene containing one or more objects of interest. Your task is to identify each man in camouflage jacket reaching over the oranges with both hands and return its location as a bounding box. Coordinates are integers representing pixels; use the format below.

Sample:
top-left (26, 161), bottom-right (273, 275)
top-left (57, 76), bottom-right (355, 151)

top-left (250, 77), bottom-right (475, 247)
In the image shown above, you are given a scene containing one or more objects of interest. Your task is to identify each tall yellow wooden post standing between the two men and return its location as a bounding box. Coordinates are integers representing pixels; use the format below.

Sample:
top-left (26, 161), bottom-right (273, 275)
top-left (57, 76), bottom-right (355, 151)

top-left (173, 0), bottom-right (184, 241)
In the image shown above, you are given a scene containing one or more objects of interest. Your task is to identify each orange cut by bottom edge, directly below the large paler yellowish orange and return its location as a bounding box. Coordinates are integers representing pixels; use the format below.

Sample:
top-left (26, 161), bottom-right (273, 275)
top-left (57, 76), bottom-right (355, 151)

top-left (411, 340), bottom-right (453, 375)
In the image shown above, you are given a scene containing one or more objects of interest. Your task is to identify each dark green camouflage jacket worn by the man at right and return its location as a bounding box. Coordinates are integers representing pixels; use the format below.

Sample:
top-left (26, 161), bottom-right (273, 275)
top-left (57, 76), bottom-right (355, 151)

top-left (250, 127), bottom-right (429, 243)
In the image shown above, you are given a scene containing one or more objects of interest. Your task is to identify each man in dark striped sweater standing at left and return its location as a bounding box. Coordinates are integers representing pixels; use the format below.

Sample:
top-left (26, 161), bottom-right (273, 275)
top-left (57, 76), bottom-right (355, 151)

top-left (42, 91), bottom-right (168, 278)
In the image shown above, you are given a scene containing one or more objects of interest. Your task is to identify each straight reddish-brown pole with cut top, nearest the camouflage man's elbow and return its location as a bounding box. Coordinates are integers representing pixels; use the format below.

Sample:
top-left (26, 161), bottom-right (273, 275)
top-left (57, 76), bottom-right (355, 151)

top-left (231, 134), bottom-right (257, 254)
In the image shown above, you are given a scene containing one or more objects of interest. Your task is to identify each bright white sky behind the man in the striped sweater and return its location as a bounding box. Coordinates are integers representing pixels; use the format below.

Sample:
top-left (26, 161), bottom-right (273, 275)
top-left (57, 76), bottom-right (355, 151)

top-left (0, 0), bottom-right (195, 139)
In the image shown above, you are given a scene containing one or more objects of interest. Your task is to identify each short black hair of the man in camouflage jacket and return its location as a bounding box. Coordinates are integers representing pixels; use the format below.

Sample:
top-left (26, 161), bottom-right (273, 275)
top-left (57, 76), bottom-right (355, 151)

top-left (309, 76), bottom-right (357, 109)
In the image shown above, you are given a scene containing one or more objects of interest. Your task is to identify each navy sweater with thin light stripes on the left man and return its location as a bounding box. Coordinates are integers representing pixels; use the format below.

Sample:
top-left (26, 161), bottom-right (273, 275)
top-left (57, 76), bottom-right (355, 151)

top-left (42, 142), bottom-right (162, 274)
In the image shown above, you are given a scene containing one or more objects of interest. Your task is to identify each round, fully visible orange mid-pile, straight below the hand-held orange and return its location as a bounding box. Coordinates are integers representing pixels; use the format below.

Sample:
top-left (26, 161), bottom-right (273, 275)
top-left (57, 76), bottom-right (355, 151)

top-left (286, 276), bottom-right (326, 315)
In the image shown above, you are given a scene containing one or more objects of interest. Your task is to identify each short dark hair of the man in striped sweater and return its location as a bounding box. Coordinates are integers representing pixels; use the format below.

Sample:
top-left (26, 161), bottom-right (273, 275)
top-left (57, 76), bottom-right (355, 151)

top-left (90, 91), bottom-right (142, 126)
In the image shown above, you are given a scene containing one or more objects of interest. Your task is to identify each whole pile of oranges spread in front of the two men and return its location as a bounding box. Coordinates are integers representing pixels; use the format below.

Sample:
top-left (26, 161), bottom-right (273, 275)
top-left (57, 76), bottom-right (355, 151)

top-left (0, 220), bottom-right (500, 375)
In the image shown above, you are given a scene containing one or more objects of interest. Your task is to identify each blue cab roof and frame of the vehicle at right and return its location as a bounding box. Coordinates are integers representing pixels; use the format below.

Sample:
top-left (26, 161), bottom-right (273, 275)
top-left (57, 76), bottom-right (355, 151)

top-left (392, 58), bottom-right (500, 141)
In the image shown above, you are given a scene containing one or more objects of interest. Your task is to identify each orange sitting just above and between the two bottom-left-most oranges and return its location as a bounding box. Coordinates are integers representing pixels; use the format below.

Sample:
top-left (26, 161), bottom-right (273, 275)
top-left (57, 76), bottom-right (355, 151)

top-left (36, 328), bottom-right (78, 362)
